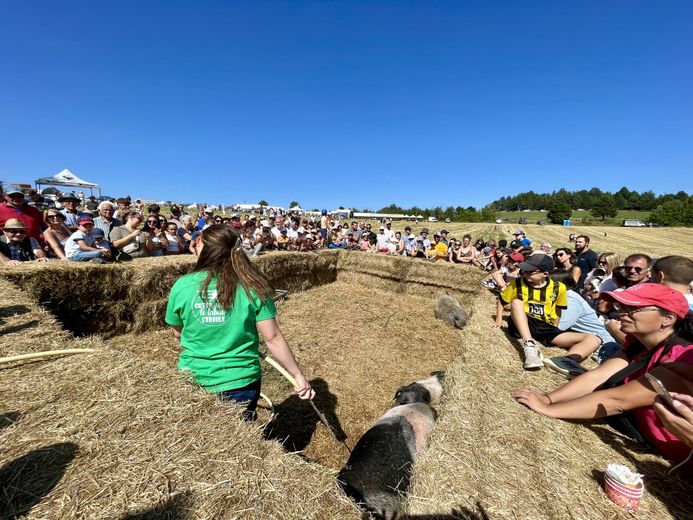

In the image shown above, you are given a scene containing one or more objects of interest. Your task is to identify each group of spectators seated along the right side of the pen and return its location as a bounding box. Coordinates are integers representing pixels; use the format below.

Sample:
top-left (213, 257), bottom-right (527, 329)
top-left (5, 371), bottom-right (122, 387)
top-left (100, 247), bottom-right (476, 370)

top-left (474, 225), bottom-right (693, 474)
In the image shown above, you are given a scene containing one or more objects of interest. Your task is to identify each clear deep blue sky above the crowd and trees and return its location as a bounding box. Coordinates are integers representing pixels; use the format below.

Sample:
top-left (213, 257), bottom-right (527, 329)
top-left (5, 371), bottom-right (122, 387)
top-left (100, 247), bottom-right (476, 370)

top-left (0, 0), bottom-right (693, 209)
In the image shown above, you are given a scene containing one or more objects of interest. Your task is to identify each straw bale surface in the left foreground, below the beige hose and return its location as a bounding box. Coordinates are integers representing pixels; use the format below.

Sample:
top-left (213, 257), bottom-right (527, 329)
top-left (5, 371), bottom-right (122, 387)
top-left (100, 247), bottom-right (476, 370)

top-left (0, 338), bottom-right (358, 519)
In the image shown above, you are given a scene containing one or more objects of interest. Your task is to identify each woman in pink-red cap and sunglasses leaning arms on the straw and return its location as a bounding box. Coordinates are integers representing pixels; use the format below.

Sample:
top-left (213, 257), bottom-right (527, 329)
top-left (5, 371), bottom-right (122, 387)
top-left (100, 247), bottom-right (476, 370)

top-left (513, 283), bottom-right (693, 473)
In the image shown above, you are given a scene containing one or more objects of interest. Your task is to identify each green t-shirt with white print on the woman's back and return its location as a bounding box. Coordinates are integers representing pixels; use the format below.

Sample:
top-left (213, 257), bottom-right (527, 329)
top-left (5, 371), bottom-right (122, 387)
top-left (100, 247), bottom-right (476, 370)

top-left (166, 272), bottom-right (277, 392)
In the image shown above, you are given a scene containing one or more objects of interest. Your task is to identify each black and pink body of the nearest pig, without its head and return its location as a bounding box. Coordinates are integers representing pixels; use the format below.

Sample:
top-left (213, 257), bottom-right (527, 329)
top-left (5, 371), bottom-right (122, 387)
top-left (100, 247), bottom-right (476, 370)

top-left (337, 403), bottom-right (437, 518)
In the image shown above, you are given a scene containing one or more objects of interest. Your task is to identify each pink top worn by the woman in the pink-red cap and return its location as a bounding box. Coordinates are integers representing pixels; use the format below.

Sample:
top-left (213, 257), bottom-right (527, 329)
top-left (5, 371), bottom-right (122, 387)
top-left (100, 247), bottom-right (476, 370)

top-left (624, 338), bottom-right (693, 463)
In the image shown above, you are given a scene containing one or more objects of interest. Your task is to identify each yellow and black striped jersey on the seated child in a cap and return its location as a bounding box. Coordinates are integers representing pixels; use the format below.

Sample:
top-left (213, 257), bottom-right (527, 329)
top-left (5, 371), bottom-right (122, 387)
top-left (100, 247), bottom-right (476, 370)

top-left (500, 277), bottom-right (568, 325)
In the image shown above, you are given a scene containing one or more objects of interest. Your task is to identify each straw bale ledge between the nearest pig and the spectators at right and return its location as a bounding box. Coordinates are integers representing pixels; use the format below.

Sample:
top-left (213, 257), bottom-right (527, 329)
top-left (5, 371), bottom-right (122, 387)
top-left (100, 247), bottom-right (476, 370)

top-left (409, 294), bottom-right (693, 519)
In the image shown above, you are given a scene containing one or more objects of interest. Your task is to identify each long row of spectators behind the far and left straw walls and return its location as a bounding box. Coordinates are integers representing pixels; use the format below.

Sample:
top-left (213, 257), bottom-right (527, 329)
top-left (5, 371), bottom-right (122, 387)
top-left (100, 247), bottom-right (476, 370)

top-left (0, 190), bottom-right (536, 266)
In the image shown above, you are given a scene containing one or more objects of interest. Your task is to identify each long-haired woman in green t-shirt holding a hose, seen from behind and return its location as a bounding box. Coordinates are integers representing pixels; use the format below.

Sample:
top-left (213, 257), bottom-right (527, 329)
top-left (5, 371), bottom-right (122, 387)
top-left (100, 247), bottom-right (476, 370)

top-left (166, 224), bottom-right (315, 419)
